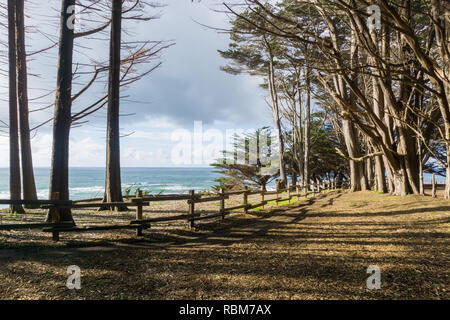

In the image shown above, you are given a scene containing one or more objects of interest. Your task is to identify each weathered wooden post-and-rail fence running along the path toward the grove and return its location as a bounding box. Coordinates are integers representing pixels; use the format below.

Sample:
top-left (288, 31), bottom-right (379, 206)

top-left (0, 181), bottom-right (336, 241)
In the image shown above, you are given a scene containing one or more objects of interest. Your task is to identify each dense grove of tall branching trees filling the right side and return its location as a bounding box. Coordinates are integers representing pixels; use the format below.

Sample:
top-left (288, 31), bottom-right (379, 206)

top-left (220, 0), bottom-right (450, 199)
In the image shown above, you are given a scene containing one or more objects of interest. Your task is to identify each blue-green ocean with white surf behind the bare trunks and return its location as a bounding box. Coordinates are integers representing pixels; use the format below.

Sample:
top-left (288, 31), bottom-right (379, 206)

top-left (0, 167), bottom-right (221, 200)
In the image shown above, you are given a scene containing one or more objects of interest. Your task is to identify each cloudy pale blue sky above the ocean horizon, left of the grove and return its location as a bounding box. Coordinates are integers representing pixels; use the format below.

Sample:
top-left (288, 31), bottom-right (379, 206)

top-left (0, 0), bottom-right (272, 167)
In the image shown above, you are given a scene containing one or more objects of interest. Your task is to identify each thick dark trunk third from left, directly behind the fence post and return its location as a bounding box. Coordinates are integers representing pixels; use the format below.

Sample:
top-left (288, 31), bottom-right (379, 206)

top-left (47, 0), bottom-right (75, 222)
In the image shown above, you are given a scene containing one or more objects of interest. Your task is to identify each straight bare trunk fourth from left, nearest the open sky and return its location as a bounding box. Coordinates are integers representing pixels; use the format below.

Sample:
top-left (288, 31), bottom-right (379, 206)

top-left (102, 0), bottom-right (127, 211)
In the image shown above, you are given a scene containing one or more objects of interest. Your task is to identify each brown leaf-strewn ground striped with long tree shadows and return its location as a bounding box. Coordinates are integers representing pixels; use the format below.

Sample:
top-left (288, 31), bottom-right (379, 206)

top-left (0, 191), bottom-right (450, 299)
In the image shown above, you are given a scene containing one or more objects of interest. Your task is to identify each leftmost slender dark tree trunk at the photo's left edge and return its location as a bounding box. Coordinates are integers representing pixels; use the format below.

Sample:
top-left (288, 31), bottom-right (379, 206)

top-left (8, 0), bottom-right (23, 212)
